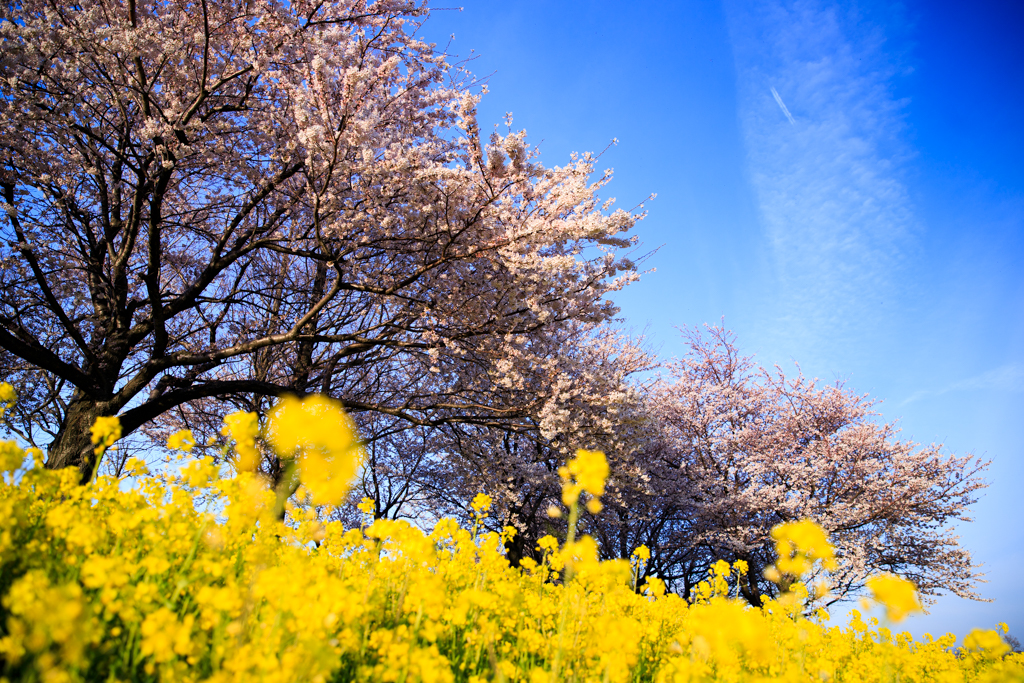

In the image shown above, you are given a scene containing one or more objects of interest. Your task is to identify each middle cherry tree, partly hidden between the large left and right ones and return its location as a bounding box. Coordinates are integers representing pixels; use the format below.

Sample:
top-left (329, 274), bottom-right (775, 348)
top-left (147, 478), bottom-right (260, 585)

top-left (428, 328), bottom-right (656, 564)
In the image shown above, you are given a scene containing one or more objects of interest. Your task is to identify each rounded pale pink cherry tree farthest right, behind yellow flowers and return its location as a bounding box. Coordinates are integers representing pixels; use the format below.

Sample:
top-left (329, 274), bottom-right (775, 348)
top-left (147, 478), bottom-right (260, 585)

top-left (622, 328), bottom-right (988, 605)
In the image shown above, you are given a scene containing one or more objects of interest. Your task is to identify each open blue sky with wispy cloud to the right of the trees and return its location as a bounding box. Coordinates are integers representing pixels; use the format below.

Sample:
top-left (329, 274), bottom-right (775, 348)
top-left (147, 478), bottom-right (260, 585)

top-left (426, 0), bottom-right (1024, 639)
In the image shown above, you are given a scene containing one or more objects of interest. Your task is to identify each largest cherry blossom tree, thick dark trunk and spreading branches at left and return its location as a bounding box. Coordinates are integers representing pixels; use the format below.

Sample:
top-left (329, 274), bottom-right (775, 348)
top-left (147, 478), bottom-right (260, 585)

top-left (0, 0), bottom-right (640, 478)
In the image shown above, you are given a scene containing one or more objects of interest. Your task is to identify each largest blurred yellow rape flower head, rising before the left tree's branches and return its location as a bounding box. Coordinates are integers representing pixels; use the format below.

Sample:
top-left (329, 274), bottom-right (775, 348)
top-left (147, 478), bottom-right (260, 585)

top-left (268, 395), bottom-right (361, 505)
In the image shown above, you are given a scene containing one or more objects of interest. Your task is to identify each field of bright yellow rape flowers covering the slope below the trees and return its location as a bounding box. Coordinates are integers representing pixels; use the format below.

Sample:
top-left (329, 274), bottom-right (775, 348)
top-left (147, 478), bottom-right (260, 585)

top-left (0, 389), bottom-right (1024, 683)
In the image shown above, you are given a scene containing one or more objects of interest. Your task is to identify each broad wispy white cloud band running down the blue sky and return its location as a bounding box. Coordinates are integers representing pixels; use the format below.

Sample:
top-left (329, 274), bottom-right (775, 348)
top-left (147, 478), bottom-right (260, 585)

top-left (727, 0), bottom-right (918, 370)
